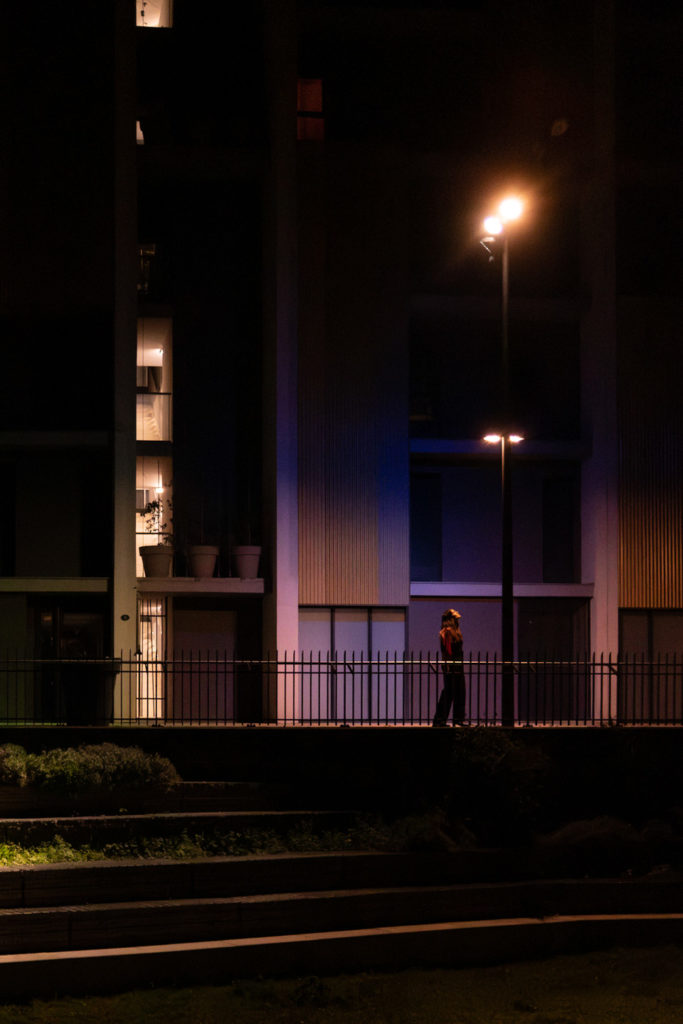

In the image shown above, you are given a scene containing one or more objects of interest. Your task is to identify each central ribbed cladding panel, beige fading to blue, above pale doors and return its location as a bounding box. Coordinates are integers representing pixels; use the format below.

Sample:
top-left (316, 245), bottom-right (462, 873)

top-left (299, 153), bottom-right (410, 605)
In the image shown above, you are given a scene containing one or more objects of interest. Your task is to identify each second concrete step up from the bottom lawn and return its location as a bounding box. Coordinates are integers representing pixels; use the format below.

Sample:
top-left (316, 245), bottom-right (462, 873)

top-left (0, 880), bottom-right (683, 953)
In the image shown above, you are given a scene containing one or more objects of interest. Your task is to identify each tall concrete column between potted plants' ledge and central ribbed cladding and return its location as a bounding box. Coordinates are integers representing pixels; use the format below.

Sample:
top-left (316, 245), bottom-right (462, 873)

top-left (263, 0), bottom-right (299, 653)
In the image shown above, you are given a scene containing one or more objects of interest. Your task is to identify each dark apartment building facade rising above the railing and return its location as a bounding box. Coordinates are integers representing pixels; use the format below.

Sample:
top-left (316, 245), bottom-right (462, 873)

top-left (0, 0), bottom-right (683, 714)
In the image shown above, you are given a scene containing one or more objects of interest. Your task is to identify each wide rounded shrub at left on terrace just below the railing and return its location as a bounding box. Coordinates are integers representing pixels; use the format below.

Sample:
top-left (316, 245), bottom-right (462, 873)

top-left (27, 743), bottom-right (180, 794)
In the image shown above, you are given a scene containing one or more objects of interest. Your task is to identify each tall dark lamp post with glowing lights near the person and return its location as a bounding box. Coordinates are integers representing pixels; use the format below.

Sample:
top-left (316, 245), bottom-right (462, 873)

top-left (481, 197), bottom-right (523, 726)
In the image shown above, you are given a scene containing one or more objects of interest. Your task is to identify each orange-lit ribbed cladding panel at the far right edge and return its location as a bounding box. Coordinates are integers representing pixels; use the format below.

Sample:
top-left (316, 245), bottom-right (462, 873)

top-left (620, 307), bottom-right (683, 608)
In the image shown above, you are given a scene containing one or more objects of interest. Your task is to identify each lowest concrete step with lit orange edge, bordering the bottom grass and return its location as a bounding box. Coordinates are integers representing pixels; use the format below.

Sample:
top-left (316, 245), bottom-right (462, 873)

top-left (0, 913), bottom-right (683, 1001)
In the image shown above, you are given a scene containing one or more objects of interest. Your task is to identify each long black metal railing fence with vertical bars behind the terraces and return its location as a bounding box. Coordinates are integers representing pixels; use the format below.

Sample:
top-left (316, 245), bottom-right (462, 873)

top-left (0, 651), bottom-right (683, 726)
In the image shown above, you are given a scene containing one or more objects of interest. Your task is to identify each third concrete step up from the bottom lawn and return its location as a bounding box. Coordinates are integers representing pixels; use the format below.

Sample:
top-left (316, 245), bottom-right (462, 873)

top-left (5, 850), bottom-right (683, 908)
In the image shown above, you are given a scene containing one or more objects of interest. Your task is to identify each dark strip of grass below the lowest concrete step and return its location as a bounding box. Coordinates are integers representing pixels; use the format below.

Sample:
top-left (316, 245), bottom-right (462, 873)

top-left (0, 946), bottom-right (683, 1024)
